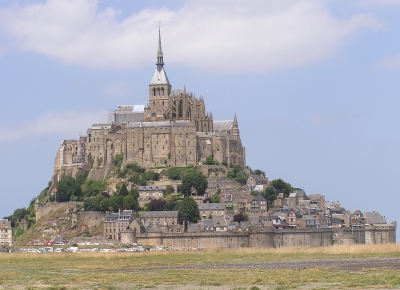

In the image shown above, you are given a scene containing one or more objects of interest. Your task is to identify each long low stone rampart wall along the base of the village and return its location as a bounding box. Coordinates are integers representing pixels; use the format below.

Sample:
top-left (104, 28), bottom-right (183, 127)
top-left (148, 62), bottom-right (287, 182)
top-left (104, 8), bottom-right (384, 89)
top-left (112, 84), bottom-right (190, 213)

top-left (130, 225), bottom-right (396, 249)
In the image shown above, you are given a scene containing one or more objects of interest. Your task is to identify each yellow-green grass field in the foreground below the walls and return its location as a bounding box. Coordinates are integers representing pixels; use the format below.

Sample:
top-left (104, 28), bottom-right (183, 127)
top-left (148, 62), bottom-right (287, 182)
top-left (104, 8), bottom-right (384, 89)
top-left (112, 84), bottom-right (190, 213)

top-left (0, 244), bottom-right (400, 290)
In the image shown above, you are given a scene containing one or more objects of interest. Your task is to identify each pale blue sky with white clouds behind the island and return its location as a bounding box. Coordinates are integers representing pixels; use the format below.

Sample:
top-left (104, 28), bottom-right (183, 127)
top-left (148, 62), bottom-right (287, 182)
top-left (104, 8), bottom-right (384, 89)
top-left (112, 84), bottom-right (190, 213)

top-left (0, 0), bottom-right (400, 238)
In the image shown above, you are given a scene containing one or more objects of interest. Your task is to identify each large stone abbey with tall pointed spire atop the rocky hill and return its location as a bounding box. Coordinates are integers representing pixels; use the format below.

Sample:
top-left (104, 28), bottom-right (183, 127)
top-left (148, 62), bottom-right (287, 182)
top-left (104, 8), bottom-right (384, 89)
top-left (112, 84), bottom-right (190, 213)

top-left (54, 30), bottom-right (246, 178)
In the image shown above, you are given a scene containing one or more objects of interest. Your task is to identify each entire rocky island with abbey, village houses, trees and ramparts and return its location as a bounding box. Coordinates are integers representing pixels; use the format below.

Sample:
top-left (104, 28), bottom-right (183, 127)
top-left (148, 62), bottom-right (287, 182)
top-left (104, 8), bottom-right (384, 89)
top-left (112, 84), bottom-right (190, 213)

top-left (0, 30), bottom-right (396, 248)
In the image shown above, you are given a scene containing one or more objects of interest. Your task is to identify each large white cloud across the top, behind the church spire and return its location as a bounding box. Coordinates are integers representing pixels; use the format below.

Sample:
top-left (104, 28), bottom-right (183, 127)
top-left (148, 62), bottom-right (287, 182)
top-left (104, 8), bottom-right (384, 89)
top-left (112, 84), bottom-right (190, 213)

top-left (0, 0), bottom-right (382, 72)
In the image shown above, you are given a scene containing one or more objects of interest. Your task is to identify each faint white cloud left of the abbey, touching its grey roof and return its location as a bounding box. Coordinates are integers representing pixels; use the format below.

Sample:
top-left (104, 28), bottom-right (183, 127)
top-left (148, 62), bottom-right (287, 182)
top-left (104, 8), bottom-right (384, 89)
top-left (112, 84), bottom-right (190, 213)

top-left (0, 111), bottom-right (107, 144)
